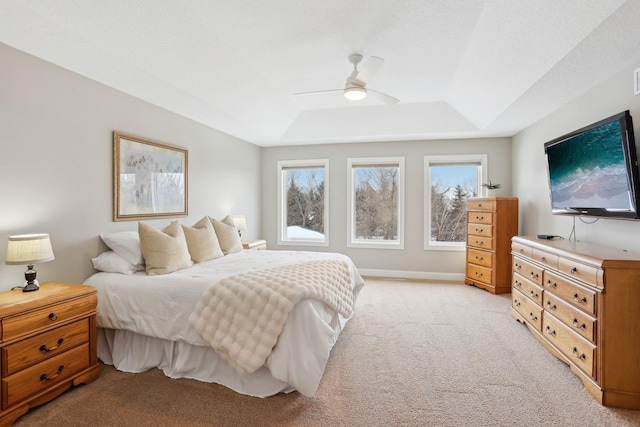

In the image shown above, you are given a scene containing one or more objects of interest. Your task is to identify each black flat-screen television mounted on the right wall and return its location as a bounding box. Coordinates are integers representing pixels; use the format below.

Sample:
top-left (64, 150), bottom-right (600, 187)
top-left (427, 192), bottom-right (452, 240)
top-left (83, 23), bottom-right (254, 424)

top-left (544, 111), bottom-right (640, 219)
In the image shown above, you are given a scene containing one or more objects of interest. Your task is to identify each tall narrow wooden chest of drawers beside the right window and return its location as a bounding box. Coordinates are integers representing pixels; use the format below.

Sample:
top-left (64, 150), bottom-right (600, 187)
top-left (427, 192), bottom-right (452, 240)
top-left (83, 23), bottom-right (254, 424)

top-left (464, 197), bottom-right (518, 294)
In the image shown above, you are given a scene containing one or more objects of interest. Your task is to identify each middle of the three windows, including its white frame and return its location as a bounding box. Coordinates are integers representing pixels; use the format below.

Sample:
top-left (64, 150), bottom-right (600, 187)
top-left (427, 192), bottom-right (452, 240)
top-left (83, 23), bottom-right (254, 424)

top-left (347, 157), bottom-right (404, 249)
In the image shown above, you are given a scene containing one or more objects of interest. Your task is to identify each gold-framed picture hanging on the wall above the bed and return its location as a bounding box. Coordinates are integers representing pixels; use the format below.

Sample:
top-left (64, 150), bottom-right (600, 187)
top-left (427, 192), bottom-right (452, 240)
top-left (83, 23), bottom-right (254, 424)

top-left (113, 131), bottom-right (189, 221)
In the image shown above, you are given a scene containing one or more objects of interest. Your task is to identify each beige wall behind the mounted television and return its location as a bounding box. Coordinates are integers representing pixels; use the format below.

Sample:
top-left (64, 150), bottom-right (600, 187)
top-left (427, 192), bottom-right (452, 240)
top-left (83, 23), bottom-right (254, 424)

top-left (513, 64), bottom-right (640, 252)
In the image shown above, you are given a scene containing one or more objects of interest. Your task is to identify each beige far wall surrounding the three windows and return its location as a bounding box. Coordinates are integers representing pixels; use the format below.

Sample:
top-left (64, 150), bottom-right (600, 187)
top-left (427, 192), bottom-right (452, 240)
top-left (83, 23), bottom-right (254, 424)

top-left (262, 138), bottom-right (512, 279)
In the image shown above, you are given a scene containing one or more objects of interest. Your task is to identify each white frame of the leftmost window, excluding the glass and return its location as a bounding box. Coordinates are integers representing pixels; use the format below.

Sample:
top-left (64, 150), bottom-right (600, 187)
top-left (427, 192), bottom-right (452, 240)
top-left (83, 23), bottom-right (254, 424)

top-left (277, 159), bottom-right (329, 247)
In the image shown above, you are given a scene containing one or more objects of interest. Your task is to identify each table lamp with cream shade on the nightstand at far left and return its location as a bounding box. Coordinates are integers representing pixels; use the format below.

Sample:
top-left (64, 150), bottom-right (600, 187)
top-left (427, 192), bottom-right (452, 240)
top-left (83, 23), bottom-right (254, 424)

top-left (6, 234), bottom-right (55, 292)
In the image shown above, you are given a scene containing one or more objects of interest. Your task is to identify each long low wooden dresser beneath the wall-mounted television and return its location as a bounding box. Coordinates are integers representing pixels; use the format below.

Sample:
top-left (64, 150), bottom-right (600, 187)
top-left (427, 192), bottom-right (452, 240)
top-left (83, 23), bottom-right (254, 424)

top-left (512, 237), bottom-right (640, 409)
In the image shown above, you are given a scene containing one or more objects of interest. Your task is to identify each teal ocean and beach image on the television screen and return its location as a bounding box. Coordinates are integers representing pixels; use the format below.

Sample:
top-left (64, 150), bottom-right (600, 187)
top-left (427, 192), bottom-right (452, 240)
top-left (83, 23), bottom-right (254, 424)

top-left (547, 121), bottom-right (632, 210)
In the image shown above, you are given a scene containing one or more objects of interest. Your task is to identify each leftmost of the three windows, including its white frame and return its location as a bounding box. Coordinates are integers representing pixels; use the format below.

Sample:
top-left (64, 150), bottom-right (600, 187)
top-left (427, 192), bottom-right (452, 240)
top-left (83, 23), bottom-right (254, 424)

top-left (278, 159), bottom-right (329, 246)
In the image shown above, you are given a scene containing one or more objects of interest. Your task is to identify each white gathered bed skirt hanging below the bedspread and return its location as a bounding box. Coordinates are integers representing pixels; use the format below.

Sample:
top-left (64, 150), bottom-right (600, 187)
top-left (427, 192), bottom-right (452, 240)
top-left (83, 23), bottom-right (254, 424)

top-left (98, 328), bottom-right (294, 397)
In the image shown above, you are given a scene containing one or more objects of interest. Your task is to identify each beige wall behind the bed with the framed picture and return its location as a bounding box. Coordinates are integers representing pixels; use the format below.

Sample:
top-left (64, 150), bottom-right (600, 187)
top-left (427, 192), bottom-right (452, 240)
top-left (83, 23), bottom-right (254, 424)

top-left (0, 44), bottom-right (261, 290)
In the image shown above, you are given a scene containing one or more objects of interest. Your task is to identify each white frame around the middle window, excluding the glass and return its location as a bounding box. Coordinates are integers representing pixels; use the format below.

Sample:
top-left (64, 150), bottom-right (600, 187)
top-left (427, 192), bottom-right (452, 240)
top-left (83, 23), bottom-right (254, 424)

top-left (347, 157), bottom-right (405, 249)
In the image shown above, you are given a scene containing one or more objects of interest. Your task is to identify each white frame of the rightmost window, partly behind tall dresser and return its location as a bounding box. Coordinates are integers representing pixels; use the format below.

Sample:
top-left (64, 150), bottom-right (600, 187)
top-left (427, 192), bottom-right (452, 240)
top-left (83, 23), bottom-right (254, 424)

top-left (422, 154), bottom-right (487, 252)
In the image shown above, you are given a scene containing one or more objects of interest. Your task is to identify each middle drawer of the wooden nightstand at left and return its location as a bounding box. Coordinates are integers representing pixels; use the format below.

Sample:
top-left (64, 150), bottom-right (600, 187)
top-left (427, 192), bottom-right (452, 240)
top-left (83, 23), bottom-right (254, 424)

top-left (2, 319), bottom-right (89, 377)
